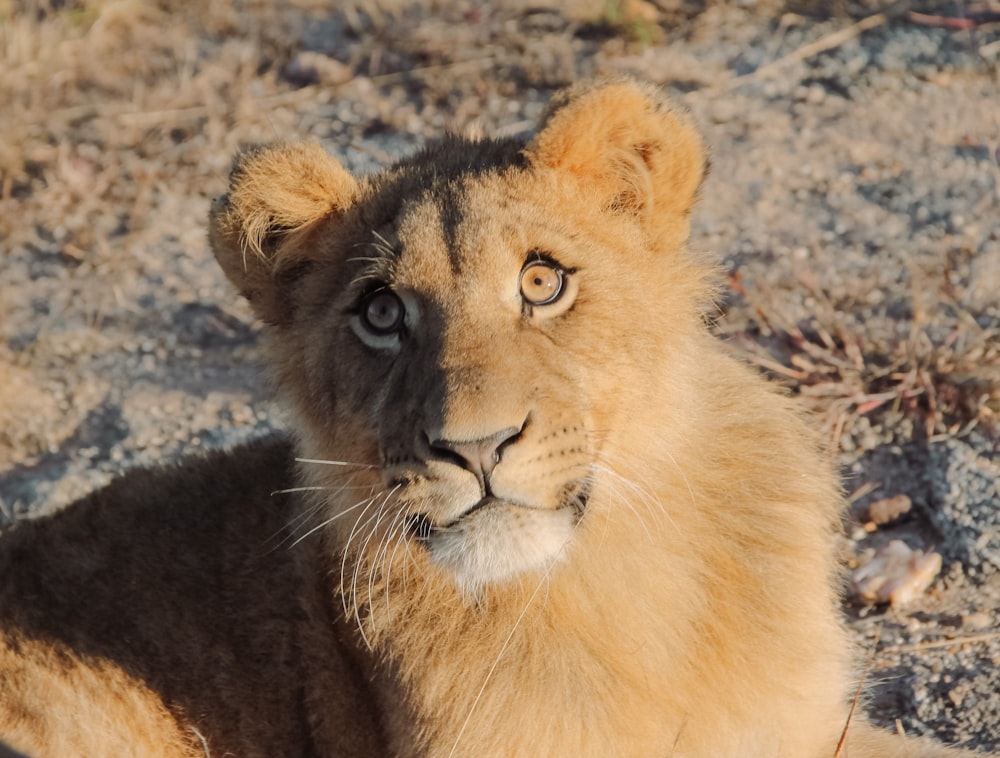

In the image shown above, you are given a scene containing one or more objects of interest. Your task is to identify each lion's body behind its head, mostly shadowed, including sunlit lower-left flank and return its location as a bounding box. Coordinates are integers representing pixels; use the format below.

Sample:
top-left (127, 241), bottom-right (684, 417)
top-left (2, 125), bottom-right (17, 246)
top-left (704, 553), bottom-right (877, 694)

top-left (0, 442), bottom-right (380, 758)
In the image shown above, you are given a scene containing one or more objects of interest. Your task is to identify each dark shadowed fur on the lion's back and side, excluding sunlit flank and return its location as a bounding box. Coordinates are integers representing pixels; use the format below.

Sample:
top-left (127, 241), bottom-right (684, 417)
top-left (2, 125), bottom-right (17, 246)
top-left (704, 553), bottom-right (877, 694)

top-left (0, 437), bottom-right (385, 758)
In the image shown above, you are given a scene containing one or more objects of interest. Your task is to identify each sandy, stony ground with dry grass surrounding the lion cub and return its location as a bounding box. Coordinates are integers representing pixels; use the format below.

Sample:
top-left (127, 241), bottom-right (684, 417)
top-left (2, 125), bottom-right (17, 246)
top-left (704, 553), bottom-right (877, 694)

top-left (0, 0), bottom-right (1000, 750)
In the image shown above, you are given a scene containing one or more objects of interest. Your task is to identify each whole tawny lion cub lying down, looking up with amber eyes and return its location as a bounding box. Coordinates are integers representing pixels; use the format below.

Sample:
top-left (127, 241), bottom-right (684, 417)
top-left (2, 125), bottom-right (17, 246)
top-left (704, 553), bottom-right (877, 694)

top-left (0, 80), bottom-right (984, 758)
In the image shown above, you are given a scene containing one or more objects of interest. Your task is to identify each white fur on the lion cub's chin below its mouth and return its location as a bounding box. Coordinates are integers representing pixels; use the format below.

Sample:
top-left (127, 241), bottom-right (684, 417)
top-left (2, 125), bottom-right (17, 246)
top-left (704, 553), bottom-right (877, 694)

top-left (427, 505), bottom-right (576, 595)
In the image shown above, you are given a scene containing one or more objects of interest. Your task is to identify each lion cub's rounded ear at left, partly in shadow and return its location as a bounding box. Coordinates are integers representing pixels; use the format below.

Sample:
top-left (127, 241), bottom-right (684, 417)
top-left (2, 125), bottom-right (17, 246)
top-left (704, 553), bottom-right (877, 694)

top-left (209, 143), bottom-right (358, 324)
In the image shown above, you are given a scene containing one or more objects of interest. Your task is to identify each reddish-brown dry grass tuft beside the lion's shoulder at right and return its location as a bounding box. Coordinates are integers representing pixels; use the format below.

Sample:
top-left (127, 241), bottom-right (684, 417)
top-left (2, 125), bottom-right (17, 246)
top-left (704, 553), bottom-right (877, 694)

top-left (728, 272), bottom-right (1000, 442)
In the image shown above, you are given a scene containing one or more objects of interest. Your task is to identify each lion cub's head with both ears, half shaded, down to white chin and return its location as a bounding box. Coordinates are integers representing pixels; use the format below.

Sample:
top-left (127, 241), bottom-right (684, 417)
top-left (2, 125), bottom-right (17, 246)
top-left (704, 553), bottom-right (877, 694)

top-left (213, 84), bottom-right (703, 590)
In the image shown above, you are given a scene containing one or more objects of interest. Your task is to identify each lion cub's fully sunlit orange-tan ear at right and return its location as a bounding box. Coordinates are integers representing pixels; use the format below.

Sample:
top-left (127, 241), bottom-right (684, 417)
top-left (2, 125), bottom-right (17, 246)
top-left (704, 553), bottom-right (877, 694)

top-left (525, 79), bottom-right (708, 228)
